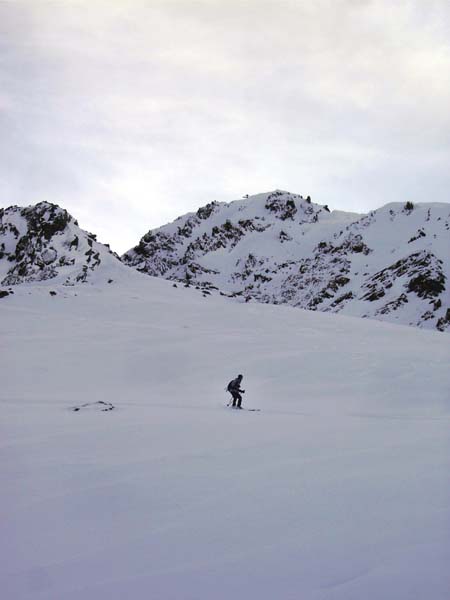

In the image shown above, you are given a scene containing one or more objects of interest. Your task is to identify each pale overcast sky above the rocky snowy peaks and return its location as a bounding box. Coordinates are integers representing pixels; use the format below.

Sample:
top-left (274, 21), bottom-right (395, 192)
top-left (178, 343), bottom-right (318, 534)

top-left (0, 0), bottom-right (450, 252)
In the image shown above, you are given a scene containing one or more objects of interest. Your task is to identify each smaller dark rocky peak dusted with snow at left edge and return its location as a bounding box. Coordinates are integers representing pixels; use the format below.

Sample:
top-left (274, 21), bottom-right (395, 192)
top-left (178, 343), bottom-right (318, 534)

top-left (0, 202), bottom-right (122, 286)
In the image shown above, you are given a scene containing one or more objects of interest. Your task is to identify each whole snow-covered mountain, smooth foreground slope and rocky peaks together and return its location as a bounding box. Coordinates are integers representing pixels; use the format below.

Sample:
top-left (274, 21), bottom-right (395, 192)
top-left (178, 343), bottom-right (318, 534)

top-left (0, 192), bottom-right (450, 600)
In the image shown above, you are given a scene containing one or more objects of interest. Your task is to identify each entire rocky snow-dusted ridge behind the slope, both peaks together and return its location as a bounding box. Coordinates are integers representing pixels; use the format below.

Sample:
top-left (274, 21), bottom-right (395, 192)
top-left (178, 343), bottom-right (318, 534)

top-left (0, 190), bottom-right (450, 331)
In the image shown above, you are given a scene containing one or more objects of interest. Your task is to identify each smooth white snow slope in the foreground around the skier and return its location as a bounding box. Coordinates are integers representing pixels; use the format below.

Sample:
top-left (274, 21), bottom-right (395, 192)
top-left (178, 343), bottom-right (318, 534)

top-left (0, 276), bottom-right (450, 600)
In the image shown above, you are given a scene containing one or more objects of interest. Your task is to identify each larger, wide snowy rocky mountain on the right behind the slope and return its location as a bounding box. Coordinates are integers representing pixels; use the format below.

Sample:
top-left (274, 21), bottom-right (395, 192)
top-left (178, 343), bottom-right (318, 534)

top-left (122, 190), bottom-right (450, 331)
